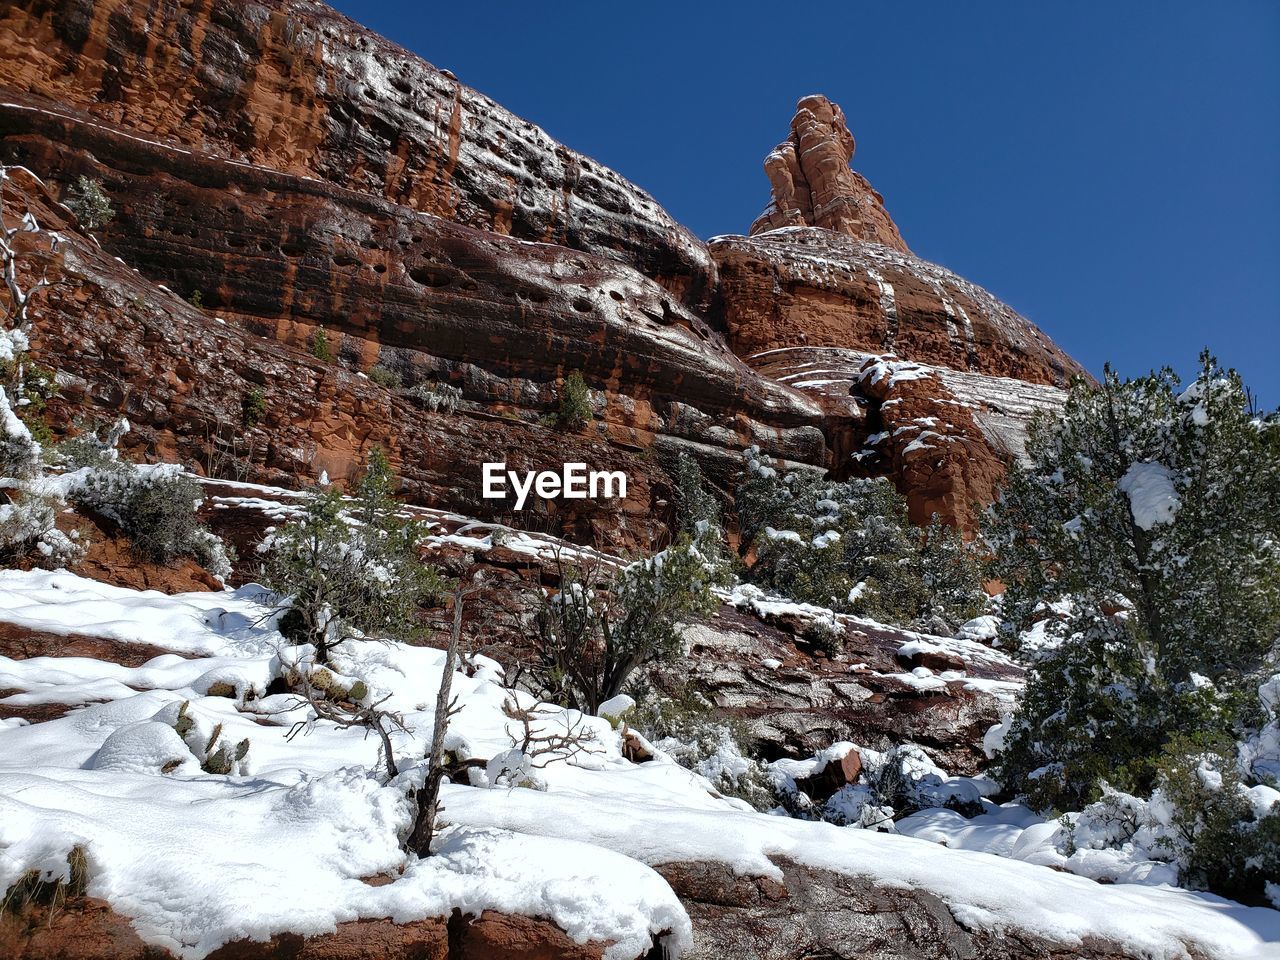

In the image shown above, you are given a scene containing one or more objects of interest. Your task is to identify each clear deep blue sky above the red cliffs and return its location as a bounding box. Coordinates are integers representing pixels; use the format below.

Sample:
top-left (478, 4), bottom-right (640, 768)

top-left (337, 0), bottom-right (1280, 407)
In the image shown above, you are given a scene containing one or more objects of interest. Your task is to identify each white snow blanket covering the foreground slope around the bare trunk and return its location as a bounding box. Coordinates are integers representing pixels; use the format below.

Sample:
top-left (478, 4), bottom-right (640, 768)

top-left (0, 571), bottom-right (1280, 960)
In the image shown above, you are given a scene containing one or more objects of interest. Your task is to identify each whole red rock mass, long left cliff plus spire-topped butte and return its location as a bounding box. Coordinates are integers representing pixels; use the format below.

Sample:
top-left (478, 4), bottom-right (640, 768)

top-left (0, 0), bottom-right (1078, 535)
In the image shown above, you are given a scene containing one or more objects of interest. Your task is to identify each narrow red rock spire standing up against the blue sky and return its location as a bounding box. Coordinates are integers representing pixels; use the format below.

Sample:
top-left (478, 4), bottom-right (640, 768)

top-left (751, 95), bottom-right (906, 253)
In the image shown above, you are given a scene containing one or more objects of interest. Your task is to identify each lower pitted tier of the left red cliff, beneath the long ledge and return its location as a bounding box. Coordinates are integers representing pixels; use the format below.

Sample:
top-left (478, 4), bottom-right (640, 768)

top-left (0, 156), bottom-right (826, 548)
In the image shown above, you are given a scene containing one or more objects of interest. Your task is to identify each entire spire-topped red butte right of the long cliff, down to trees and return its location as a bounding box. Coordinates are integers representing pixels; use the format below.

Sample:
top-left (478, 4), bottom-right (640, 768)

top-left (709, 96), bottom-right (1084, 527)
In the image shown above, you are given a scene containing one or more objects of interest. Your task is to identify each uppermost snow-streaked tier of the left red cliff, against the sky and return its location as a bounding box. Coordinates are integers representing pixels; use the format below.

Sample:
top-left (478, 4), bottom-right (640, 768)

top-left (0, 0), bottom-right (713, 303)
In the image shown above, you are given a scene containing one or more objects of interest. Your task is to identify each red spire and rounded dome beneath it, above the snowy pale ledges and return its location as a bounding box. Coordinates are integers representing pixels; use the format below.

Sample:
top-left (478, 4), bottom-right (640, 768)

top-left (732, 96), bottom-right (1083, 385)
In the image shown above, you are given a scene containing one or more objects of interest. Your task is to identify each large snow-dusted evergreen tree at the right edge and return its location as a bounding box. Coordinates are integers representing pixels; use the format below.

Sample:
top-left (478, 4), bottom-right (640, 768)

top-left (988, 355), bottom-right (1280, 809)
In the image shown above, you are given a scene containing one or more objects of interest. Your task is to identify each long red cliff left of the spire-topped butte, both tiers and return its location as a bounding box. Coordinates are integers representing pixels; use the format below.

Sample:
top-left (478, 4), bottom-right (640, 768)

top-left (0, 0), bottom-right (828, 549)
